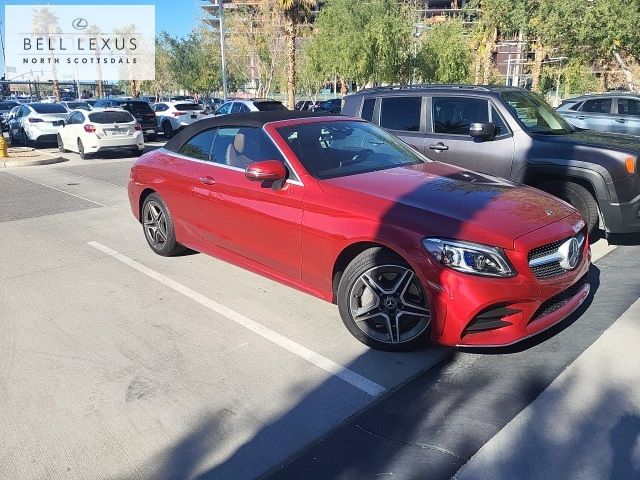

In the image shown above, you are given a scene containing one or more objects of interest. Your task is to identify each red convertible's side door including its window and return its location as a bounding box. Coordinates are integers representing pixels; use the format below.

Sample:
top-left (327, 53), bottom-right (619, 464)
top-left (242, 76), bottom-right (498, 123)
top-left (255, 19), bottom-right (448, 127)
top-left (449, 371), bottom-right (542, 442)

top-left (194, 127), bottom-right (304, 278)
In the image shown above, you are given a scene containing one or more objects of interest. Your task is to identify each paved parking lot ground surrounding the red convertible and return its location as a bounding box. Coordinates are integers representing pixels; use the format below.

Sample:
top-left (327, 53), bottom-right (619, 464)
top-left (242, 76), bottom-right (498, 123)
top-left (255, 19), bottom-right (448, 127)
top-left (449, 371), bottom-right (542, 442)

top-left (0, 142), bottom-right (640, 480)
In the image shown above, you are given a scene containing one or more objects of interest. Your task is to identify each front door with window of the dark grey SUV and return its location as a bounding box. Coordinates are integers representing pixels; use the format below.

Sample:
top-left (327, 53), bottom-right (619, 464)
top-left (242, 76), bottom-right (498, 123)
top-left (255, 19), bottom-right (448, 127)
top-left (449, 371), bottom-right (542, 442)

top-left (425, 95), bottom-right (514, 178)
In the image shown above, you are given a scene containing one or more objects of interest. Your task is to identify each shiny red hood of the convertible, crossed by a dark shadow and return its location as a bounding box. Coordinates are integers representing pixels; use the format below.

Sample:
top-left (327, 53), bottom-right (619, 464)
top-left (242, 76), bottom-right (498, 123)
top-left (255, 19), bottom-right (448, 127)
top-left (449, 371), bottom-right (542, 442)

top-left (320, 162), bottom-right (576, 249)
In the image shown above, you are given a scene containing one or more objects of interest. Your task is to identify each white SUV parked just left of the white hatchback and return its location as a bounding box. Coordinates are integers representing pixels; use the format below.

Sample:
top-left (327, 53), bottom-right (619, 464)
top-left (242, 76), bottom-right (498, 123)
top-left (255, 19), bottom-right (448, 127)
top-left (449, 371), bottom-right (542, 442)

top-left (9, 103), bottom-right (67, 145)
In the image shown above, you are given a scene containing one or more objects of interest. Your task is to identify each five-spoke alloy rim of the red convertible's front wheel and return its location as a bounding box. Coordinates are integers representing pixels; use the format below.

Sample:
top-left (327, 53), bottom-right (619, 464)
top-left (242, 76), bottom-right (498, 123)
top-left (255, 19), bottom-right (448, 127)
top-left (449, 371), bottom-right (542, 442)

top-left (349, 265), bottom-right (431, 344)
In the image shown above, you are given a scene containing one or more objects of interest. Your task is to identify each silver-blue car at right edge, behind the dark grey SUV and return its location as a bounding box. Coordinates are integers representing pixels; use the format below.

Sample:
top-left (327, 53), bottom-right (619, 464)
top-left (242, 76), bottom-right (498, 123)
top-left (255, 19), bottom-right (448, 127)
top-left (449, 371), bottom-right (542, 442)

top-left (556, 93), bottom-right (640, 135)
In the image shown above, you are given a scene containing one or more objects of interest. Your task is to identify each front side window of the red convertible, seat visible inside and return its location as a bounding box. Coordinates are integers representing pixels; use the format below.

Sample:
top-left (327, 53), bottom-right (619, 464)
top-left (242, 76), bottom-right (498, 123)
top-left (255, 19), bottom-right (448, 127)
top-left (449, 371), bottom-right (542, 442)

top-left (212, 127), bottom-right (292, 173)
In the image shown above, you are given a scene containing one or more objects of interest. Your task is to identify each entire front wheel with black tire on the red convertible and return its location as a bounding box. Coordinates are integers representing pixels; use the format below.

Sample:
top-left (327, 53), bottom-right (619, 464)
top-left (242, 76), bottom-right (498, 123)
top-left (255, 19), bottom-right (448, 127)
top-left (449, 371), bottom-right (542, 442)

top-left (337, 247), bottom-right (431, 352)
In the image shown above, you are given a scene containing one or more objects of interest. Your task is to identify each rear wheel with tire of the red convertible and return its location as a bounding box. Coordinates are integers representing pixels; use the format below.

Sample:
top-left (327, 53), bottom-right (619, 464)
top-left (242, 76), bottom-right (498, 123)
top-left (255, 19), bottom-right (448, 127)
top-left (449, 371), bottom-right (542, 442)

top-left (141, 193), bottom-right (186, 257)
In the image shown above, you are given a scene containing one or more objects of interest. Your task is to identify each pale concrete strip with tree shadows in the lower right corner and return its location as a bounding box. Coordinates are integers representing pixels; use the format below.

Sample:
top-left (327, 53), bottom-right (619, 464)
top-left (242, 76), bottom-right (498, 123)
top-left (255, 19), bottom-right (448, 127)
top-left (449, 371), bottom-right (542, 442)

top-left (454, 299), bottom-right (640, 480)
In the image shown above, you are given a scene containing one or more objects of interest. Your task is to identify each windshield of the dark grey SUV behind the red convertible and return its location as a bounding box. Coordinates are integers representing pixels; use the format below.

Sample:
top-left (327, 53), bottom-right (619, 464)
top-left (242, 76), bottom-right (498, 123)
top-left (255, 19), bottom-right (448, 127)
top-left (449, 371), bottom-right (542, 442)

top-left (502, 91), bottom-right (575, 135)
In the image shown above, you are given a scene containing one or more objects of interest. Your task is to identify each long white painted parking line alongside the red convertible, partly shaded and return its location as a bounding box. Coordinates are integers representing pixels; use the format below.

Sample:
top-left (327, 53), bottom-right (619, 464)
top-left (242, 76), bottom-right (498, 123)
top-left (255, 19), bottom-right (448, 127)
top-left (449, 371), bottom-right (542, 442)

top-left (87, 242), bottom-right (385, 397)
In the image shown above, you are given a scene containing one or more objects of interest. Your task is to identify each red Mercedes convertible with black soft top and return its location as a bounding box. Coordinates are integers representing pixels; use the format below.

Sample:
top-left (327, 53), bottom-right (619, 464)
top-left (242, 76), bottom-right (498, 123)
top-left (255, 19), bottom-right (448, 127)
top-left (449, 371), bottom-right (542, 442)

top-left (128, 111), bottom-right (590, 351)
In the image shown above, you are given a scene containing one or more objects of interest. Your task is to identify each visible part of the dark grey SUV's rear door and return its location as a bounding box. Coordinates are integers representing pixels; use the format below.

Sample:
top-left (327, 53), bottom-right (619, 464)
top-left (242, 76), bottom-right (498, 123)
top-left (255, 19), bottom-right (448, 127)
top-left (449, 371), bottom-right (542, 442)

top-left (378, 95), bottom-right (425, 153)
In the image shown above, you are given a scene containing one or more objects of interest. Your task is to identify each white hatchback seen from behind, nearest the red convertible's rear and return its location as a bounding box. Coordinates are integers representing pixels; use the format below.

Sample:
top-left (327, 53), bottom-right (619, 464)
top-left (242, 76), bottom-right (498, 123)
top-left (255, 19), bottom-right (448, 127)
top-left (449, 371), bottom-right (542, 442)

top-left (58, 108), bottom-right (144, 159)
